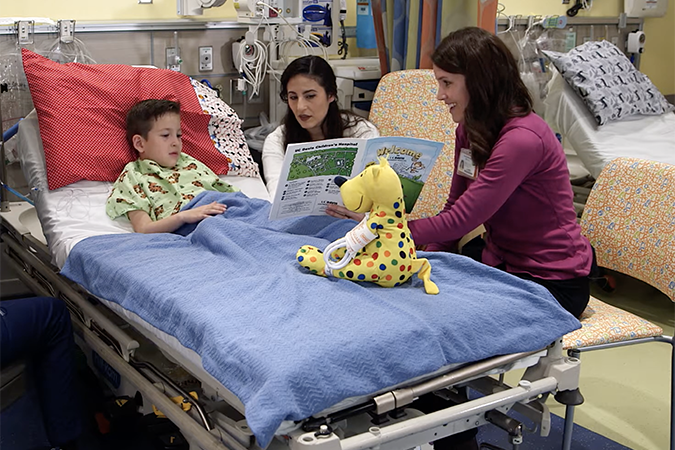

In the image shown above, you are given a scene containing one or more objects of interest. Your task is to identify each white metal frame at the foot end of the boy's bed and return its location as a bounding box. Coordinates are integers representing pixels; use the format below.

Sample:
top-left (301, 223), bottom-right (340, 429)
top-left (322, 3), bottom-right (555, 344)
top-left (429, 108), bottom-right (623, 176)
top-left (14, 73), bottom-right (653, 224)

top-left (289, 340), bottom-right (580, 450)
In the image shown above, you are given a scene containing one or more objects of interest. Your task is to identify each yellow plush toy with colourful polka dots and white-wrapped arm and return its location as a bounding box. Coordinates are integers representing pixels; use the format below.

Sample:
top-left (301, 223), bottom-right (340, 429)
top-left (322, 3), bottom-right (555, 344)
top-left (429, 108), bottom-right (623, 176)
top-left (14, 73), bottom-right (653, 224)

top-left (296, 158), bottom-right (438, 294)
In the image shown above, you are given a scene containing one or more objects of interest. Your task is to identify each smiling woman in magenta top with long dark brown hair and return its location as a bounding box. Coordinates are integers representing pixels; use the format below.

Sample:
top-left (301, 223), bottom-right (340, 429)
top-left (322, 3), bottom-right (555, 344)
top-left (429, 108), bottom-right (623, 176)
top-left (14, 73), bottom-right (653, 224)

top-left (410, 28), bottom-right (593, 317)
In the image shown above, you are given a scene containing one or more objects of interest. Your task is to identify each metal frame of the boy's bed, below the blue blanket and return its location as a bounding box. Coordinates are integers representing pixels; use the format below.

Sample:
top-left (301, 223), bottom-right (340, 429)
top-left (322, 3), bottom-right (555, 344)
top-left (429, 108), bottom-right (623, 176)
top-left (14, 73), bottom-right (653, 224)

top-left (0, 202), bottom-right (580, 450)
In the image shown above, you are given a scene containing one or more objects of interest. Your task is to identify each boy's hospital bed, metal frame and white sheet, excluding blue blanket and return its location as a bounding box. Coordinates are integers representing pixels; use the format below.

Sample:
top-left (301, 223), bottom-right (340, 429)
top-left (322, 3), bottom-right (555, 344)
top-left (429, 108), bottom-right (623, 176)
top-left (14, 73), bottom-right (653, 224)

top-left (2, 110), bottom-right (579, 449)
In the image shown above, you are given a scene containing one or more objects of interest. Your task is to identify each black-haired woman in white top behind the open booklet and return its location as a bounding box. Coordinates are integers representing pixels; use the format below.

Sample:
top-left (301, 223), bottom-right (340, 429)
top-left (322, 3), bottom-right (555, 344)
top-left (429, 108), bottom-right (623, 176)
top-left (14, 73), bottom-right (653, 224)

top-left (262, 56), bottom-right (379, 198)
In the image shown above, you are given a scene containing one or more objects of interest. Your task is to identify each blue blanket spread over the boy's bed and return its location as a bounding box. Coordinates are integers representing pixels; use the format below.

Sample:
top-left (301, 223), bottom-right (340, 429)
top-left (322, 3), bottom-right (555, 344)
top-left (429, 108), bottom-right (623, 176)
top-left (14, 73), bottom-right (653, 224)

top-left (62, 192), bottom-right (580, 447)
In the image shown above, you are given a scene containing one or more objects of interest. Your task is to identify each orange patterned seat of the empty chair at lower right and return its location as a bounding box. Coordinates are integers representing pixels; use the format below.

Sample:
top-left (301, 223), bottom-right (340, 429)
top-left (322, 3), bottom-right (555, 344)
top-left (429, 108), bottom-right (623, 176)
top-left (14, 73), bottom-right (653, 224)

top-left (563, 297), bottom-right (663, 350)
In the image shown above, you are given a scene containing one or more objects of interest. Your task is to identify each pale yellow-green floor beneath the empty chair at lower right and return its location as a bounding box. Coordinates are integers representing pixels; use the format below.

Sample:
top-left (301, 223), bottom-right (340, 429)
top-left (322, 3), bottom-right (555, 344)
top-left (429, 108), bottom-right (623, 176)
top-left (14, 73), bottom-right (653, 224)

top-left (507, 274), bottom-right (675, 450)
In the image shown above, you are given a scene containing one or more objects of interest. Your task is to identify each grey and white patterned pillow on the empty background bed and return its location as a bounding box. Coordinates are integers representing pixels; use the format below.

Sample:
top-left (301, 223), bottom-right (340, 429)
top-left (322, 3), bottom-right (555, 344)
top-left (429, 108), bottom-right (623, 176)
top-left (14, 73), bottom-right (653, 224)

top-left (544, 41), bottom-right (673, 125)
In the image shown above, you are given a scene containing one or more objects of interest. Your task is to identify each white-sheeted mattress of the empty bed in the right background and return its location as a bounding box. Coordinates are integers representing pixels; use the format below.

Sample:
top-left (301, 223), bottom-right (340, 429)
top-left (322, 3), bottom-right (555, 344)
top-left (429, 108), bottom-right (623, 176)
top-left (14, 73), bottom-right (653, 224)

top-left (544, 67), bottom-right (675, 178)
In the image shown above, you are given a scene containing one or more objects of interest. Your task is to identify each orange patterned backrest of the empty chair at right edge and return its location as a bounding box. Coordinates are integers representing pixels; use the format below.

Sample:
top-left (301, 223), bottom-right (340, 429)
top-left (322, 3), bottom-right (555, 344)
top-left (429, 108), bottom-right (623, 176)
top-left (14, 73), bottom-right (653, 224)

top-left (581, 158), bottom-right (675, 301)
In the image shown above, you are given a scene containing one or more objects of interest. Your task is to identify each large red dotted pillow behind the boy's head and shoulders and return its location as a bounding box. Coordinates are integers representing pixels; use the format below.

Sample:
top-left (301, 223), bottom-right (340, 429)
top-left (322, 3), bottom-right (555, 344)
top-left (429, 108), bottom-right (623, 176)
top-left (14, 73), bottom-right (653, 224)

top-left (22, 49), bottom-right (257, 189)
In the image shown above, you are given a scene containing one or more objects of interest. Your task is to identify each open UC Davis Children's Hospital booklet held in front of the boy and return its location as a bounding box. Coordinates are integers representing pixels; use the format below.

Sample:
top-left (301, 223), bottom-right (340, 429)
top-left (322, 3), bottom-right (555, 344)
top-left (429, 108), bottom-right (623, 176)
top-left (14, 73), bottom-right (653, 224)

top-left (270, 136), bottom-right (443, 220)
